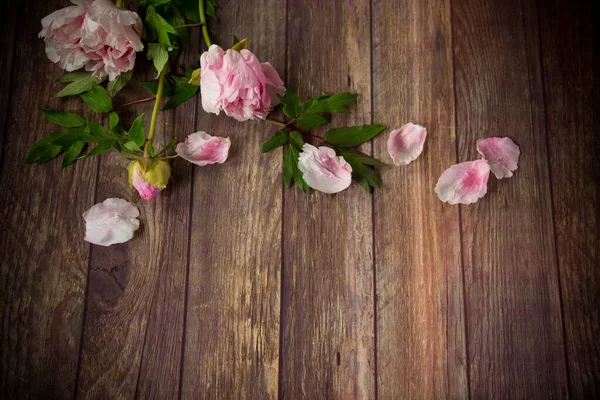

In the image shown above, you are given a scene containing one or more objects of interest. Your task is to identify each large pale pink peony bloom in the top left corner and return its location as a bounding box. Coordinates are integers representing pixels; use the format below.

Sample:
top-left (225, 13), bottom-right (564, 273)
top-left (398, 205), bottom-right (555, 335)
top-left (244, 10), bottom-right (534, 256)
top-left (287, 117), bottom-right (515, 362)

top-left (39, 0), bottom-right (144, 81)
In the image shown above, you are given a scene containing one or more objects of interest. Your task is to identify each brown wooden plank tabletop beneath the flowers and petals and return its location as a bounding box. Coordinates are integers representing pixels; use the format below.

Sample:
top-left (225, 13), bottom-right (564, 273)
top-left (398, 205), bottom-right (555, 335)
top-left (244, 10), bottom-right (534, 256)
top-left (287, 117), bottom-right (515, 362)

top-left (0, 0), bottom-right (600, 399)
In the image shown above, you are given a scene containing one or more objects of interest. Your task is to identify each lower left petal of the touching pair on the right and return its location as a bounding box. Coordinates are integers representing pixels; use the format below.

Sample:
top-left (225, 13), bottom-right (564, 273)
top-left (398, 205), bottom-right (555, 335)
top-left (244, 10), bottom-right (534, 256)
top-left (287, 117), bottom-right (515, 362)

top-left (435, 160), bottom-right (490, 204)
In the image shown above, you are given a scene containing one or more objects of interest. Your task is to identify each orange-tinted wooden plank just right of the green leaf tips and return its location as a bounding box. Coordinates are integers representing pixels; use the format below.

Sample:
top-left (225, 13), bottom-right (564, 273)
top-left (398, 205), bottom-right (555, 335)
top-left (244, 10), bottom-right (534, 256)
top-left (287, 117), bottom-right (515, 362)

top-left (373, 0), bottom-right (468, 399)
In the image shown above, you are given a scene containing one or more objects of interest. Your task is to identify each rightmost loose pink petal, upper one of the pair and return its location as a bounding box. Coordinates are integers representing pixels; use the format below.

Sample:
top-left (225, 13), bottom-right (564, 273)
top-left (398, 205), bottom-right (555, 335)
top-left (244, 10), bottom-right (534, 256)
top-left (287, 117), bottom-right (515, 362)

top-left (477, 137), bottom-right (521, 179)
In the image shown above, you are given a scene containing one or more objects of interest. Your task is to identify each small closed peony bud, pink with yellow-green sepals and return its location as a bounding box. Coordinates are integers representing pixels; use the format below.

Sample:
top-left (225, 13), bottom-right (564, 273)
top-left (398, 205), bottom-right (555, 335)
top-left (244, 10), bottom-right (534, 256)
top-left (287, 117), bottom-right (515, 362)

top-left (129, 159), bottom-right (171, 200)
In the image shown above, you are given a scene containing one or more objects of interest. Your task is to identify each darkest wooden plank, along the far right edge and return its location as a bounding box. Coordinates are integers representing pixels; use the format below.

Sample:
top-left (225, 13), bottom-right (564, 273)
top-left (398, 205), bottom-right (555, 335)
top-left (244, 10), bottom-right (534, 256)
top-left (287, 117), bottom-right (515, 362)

top-left (540, 0), bottom-right (600, 399)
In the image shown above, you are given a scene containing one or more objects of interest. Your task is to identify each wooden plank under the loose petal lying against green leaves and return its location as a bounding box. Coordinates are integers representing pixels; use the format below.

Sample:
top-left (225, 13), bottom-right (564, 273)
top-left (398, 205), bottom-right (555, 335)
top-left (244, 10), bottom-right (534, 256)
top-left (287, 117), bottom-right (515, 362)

top-left (279, 0), bottom-right (375, 399)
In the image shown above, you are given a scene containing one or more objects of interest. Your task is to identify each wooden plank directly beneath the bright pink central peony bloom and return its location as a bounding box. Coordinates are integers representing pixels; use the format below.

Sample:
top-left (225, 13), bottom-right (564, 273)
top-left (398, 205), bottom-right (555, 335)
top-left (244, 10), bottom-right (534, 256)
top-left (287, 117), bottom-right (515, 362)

top-left (182, 0), bottom-right (285, 399)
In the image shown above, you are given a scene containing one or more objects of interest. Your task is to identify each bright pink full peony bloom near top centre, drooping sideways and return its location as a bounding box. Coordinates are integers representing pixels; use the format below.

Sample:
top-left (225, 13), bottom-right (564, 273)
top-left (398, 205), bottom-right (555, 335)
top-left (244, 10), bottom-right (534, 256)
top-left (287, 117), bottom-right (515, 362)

top-left (200, 45), bottom-right (285, 121)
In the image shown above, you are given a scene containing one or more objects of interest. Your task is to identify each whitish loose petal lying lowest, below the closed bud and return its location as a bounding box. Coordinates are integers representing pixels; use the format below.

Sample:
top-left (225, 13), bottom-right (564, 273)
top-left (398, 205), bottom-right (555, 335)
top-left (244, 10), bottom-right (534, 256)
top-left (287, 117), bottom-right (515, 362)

top-left (83, 198), bottom-right (140, 246)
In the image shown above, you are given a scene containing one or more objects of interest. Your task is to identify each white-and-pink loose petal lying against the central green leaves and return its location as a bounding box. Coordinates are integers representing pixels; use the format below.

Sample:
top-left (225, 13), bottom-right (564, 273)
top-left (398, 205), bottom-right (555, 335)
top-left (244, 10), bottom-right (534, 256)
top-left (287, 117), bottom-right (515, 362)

top-left (298, 144), bottom-right (352, 193)
